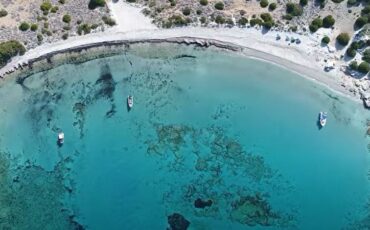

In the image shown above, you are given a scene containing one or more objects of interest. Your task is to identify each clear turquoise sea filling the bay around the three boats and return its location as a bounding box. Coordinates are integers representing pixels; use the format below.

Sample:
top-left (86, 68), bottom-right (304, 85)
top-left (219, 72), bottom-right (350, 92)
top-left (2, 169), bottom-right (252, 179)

top-left (0, 44), bottom-right (370, 230)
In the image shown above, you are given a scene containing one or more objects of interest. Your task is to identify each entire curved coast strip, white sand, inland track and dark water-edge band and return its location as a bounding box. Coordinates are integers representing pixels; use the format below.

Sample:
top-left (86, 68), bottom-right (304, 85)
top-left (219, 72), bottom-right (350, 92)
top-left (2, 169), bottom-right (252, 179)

top-left (0, 2), bottom-right (370, 102)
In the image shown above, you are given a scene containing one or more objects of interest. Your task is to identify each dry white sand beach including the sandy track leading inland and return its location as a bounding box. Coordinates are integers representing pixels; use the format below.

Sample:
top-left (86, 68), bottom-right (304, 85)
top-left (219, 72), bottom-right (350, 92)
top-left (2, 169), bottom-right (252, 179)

top-left (0, 1), bottom-right (359, 101)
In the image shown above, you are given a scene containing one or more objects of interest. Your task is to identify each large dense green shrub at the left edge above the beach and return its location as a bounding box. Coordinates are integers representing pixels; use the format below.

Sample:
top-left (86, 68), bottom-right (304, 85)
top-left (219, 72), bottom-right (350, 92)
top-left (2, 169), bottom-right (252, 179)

top-left (0, 40), bottom-right (26, 67)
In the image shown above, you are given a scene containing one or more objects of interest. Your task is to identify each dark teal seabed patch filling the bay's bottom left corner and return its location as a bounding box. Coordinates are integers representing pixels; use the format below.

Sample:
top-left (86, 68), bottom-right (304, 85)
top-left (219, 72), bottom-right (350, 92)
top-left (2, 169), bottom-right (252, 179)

top-left (0, 152), bottom-right (83, 230)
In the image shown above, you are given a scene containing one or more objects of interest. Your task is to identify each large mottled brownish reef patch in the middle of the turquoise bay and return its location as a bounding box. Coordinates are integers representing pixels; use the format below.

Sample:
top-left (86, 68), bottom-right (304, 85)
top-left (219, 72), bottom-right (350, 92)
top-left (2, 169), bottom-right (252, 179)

top-left (146, 124), bottom-right (294, 227)
